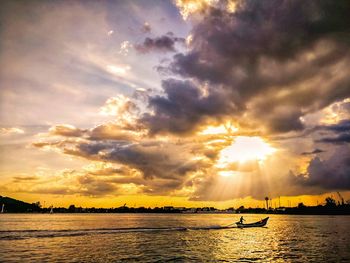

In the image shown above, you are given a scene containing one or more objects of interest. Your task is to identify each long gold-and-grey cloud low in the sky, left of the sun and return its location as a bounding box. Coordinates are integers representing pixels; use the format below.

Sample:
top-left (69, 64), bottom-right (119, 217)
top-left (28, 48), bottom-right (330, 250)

top-left (33, 131), bottom-right (213, 195)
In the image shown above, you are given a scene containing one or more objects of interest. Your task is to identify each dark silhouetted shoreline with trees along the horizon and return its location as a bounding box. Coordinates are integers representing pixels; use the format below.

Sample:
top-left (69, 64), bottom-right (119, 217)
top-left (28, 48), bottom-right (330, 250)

top-left (0, 196), bottom-right (350, 215)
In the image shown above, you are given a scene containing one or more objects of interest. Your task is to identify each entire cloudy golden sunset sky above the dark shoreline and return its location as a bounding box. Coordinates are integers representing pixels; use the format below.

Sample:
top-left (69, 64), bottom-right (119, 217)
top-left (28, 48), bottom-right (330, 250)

top-left (0, 0), bottom-right (350, 208)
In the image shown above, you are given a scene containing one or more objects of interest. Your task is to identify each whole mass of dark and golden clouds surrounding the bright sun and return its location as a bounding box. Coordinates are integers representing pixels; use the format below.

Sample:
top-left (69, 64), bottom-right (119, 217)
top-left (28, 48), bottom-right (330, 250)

top-left (6, 0), bottom-right (350, 200)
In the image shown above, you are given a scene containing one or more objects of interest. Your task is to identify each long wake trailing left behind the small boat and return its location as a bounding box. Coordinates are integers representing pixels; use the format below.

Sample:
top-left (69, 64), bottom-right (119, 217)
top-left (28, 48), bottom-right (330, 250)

top-left (0, 225), bottom-right (236, 240)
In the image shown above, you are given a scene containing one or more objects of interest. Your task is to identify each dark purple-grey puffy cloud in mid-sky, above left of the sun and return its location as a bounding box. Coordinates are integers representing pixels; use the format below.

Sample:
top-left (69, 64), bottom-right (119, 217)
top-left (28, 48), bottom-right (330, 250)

top-left (141, 79), bottom-right (235, 133)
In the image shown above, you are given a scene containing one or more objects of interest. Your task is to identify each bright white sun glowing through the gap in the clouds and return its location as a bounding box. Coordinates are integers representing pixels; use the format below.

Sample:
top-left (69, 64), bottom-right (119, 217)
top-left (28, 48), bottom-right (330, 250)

top-left (217, 136), bottom-right (276, 168)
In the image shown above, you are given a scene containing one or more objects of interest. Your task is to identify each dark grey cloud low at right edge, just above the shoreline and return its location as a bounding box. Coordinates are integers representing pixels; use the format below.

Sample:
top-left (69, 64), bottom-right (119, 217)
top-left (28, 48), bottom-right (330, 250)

top-left (295, 146), bottom-right (350, 190)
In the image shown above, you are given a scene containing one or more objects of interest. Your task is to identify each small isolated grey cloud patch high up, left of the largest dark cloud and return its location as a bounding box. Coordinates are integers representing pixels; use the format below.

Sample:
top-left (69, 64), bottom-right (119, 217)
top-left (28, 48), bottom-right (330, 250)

top-left (135, 32), bottom-right (185, 53)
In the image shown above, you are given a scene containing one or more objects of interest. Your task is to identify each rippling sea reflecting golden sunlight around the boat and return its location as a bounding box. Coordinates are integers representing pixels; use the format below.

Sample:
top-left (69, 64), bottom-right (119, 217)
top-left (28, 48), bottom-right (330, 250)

top-left (0, 214), bottom-right (350, 262)
